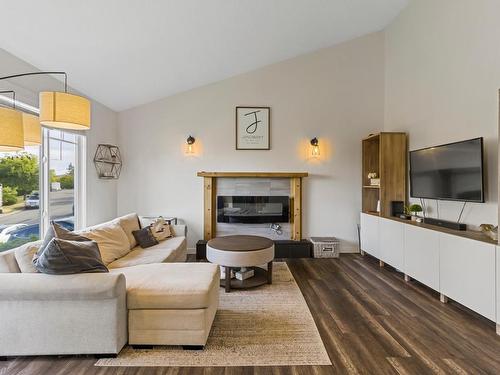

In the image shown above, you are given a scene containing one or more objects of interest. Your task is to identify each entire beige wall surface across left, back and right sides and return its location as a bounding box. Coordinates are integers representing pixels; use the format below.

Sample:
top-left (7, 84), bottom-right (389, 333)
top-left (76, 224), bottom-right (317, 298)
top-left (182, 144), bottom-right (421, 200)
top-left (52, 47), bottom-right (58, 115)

top-left (0, 0), bottom-right (500, 242)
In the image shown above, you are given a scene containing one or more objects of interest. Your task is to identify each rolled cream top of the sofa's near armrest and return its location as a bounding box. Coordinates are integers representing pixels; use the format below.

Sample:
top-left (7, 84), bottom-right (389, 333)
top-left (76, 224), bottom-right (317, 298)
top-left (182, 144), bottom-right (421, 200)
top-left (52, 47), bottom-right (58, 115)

top-left (0, 273), bottom-right (126, 301)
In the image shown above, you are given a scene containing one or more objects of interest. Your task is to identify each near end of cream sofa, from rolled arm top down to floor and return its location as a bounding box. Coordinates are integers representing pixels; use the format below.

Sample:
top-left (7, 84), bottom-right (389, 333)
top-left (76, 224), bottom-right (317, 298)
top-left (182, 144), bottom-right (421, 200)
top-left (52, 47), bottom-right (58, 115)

top-left (0, 272), bottom-right (127, 357)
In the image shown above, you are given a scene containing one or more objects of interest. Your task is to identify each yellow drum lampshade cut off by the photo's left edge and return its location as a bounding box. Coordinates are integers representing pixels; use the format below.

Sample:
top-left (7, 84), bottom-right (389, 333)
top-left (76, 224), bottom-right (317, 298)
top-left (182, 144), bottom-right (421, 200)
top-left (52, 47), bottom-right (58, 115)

top-left (0, 108), bottom-right (24, 152)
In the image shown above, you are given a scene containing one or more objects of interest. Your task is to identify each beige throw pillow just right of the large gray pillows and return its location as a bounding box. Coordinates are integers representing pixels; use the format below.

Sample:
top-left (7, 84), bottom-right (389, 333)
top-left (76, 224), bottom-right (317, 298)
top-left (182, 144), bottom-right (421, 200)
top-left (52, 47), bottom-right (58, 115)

top-left (78, 222), bottom-right (130, 265)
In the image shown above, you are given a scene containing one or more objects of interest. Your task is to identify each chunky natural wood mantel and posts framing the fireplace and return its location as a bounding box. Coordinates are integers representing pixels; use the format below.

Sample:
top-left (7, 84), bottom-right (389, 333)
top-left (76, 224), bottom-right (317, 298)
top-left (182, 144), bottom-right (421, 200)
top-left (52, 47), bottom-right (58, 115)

top-left (197, 171), bottom-right (309, 241)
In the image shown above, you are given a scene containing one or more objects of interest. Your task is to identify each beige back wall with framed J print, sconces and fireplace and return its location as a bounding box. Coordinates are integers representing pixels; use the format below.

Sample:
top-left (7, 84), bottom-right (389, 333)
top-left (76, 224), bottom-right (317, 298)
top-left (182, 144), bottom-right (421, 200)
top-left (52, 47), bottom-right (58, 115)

top-left (118, 33), bottom-right (384, 251)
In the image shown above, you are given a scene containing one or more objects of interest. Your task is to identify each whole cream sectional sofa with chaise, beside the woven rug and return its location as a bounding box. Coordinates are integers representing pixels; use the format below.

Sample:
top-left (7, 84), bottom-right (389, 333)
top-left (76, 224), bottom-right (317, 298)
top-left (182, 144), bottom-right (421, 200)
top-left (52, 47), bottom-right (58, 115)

top-left (0, 214), bottom-right (220, 356)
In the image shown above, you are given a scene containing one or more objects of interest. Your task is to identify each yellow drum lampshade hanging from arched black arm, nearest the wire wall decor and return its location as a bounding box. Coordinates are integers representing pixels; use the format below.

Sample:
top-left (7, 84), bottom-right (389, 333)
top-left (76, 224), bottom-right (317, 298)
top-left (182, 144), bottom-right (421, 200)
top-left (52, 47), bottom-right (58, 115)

top-left (39, 91), bottom-right (90, 130)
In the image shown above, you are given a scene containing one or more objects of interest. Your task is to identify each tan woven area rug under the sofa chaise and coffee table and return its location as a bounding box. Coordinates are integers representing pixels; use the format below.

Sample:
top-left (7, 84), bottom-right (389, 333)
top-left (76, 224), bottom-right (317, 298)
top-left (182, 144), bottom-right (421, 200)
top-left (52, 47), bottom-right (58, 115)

top-left (95, 262), bottom-right (331, 367)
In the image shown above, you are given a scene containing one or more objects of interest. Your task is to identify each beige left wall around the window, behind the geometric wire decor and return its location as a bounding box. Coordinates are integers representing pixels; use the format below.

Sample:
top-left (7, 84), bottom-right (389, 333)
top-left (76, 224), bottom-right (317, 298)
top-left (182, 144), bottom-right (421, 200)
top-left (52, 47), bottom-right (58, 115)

top-left (0, 49), bottom-right (117, 225)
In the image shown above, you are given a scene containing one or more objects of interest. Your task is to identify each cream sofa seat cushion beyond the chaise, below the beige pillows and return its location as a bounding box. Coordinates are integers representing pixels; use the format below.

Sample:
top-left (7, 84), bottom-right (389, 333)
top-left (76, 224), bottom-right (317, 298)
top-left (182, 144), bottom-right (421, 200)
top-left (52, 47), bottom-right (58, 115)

top-left (108, 237), bottom-right (186, 269)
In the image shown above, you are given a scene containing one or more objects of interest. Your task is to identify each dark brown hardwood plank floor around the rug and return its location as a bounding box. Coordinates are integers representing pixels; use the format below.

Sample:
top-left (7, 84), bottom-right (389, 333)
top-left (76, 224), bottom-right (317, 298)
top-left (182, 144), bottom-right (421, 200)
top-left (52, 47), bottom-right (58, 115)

top-left (0, 254), bottom-right (500, 375)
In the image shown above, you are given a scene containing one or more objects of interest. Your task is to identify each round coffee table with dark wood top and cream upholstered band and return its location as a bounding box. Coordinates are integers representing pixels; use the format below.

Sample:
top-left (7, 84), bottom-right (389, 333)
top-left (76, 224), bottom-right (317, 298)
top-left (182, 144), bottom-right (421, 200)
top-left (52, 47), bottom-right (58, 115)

top-left (207, 235), bottom-right (274, 293)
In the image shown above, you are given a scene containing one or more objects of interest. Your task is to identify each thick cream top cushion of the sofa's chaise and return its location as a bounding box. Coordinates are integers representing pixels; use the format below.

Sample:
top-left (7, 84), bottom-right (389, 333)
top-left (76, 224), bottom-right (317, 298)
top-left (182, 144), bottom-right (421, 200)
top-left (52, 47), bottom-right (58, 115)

top-left (111, 263), bottom-right (220, 310)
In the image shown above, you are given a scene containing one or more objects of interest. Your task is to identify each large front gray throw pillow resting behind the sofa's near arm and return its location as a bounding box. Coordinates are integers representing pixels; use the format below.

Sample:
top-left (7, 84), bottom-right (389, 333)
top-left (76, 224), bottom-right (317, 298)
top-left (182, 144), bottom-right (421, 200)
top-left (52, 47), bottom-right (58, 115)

top-left (34, 238), bottom-right (109, 275)
